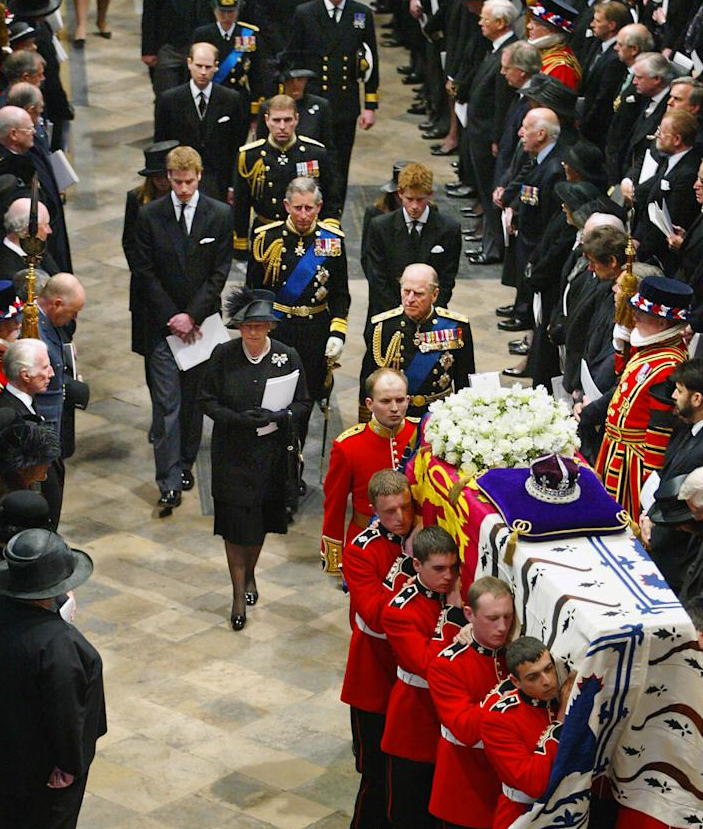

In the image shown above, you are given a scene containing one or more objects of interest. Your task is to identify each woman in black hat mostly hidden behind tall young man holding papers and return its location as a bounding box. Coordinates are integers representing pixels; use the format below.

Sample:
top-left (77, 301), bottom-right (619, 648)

top-left (122, 141), bottom-right (178, 356)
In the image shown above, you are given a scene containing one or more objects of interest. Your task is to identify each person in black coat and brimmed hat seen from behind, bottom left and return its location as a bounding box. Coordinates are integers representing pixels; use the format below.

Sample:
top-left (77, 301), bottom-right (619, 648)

top-left (0, 529), bottom-right (107, 829)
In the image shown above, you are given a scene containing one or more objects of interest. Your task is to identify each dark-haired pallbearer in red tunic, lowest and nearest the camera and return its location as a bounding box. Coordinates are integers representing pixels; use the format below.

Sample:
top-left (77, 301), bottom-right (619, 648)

top-left (481, 636), bottom-right (573, 829)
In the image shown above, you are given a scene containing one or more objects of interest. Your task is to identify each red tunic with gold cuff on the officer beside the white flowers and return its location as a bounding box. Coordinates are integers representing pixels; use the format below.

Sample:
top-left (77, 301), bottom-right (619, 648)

top-left (320, 418), bottom-right (417, 573)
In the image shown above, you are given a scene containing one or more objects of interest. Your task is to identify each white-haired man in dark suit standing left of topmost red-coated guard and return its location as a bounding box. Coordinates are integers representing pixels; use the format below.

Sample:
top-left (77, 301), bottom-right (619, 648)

top-left (466, 0), bottom-right (517, 265)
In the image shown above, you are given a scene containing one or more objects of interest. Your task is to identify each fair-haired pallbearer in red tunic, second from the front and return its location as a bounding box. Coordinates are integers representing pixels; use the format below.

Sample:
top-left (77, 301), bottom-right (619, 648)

top-left (427, 576), bottom-right (514, 829)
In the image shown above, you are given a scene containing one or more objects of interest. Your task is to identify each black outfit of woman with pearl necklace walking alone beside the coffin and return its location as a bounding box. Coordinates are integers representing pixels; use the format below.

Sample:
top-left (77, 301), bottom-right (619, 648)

top-left (199, 340), bottom-right (312, 546)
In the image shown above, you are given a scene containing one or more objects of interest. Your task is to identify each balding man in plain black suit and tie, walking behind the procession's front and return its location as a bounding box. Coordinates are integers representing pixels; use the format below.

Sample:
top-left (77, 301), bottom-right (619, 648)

top-left (154, 43), bottom-right (249, 202)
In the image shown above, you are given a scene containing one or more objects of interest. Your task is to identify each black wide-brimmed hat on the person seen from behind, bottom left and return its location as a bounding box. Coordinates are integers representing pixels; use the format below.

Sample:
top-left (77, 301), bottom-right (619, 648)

top-left (0, 528), bottom-right (93, 599)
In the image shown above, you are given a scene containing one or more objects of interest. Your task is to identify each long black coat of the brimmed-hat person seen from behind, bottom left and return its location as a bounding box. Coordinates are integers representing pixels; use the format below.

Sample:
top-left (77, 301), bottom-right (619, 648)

top-left (0, 597), bottom-right (107, 829)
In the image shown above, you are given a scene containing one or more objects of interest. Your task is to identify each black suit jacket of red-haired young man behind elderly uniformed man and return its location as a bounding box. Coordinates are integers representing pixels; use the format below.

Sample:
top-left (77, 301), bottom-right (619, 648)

top-left (366, 208), bottom-right (461, 320)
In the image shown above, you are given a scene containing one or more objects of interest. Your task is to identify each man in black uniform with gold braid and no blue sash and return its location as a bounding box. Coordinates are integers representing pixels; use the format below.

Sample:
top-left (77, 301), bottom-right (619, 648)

top-left (234, 95), bottom-right (341, 259)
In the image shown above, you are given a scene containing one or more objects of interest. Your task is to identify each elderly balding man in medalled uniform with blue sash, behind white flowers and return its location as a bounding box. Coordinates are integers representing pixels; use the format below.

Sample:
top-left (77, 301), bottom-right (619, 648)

top-left (360, 264), bottom-right (475, 419)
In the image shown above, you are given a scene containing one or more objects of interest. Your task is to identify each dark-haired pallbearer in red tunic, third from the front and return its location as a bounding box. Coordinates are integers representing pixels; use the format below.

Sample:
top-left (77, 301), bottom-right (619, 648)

top-left (381, 527), bottom-right (464, 829)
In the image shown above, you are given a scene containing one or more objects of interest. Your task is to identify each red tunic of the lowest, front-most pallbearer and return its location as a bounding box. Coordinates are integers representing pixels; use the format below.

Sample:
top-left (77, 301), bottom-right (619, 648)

top-left (481, 688), bottom-right (561, 829)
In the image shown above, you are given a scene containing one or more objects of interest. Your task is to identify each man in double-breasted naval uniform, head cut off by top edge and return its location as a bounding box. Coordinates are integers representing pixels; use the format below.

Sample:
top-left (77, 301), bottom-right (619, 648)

top-left (288, 0), bottom-right (378, 206)
